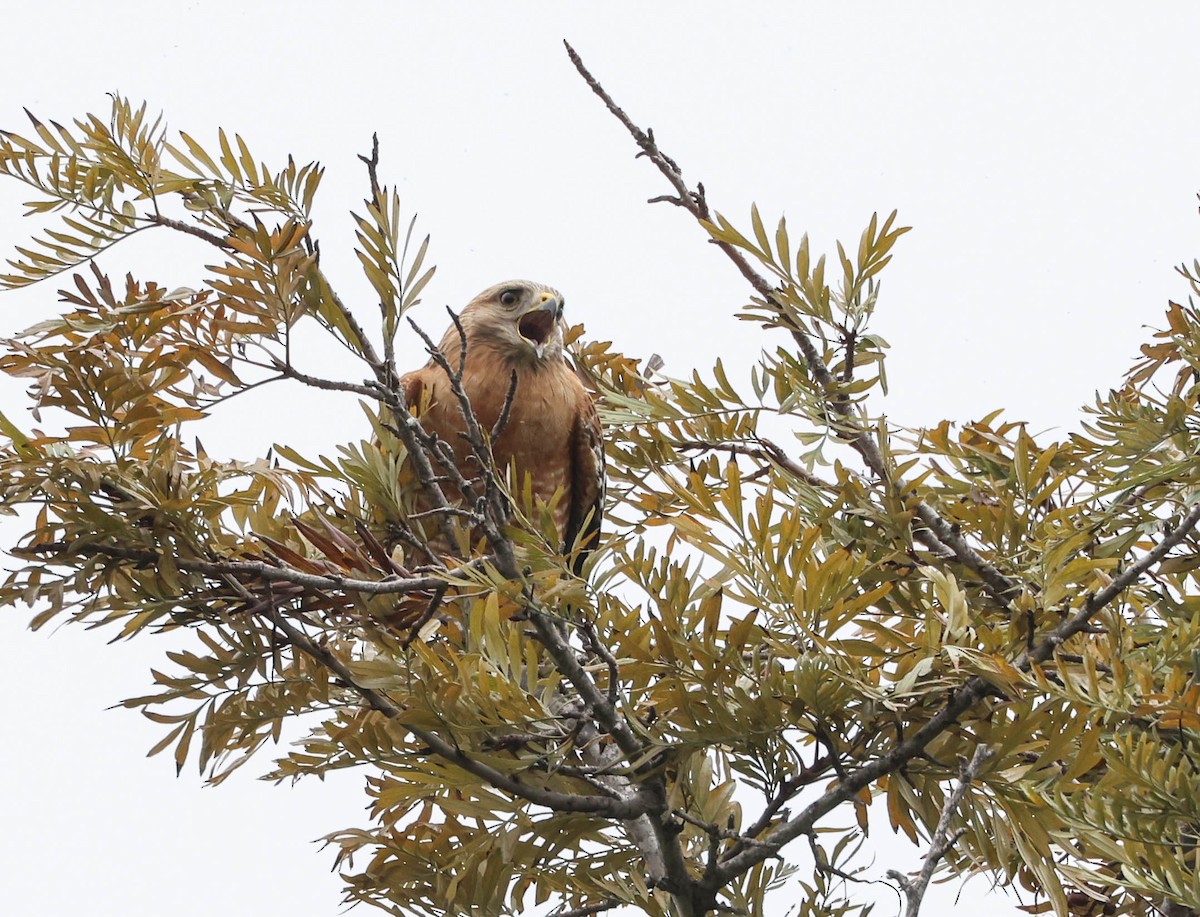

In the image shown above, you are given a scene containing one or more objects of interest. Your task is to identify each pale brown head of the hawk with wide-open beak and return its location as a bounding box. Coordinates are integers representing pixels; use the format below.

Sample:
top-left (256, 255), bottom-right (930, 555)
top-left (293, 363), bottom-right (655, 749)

top-left (453, 280), bottom-right (563, 366)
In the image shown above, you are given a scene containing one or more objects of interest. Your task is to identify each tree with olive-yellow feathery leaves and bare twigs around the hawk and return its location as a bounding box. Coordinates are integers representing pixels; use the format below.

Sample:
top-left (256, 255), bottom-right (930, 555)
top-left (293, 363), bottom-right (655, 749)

top-left (0, 42), bottom-right (1200, 917)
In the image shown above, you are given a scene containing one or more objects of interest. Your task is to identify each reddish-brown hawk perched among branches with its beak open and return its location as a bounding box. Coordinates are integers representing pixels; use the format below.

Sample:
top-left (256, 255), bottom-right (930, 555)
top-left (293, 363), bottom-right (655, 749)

top-left (400, 280), bottom-right (604, 573)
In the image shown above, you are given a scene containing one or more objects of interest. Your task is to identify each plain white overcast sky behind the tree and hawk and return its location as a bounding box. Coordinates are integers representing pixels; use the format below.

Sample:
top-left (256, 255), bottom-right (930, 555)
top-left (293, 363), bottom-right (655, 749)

top-left (0, 0), bottom-right (1200, 917)
